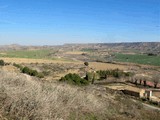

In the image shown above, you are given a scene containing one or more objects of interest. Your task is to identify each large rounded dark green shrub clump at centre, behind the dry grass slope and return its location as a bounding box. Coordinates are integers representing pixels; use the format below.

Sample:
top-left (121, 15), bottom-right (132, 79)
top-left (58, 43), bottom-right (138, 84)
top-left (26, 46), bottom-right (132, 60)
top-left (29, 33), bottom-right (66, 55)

top-left (60, 73), bottom-right (89, 85)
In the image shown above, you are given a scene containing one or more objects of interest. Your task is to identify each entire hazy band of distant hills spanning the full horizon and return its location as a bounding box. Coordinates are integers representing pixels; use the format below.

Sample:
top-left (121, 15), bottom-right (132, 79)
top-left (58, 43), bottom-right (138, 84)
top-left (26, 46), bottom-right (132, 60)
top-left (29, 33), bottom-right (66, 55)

top-left (0, 42), bottom-right (160, 54)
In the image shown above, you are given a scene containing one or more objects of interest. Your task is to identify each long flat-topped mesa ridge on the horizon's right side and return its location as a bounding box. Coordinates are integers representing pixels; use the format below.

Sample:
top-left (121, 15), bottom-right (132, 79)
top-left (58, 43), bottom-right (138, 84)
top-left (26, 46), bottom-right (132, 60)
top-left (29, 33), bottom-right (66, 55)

top-left (64, 42), bottom-right (160, 54)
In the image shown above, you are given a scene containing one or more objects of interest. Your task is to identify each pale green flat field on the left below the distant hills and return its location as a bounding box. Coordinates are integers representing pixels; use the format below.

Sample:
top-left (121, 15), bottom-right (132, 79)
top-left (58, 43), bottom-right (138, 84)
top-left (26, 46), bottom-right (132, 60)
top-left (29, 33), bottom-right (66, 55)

top-left (0, 49), bottom-right (54, 59)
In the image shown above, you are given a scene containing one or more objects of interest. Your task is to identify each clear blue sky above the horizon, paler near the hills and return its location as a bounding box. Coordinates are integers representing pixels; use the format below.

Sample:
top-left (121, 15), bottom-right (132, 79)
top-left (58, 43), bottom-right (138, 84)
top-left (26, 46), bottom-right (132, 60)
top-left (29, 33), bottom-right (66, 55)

top-left (0, 0), bottom-right (160, 45)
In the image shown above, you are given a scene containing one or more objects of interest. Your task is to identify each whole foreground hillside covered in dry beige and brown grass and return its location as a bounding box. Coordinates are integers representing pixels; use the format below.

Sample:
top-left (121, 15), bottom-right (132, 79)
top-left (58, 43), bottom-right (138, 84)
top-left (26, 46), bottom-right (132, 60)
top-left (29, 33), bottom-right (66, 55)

top-left (0, 70), bottom-right (160, 120)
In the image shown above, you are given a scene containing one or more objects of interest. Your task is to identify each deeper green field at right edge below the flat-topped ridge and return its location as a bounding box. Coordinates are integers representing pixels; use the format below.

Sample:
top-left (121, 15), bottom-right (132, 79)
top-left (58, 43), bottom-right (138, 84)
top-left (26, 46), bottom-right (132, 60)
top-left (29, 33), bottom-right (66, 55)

top-left (114, 53), bottom-right (160, 66)
